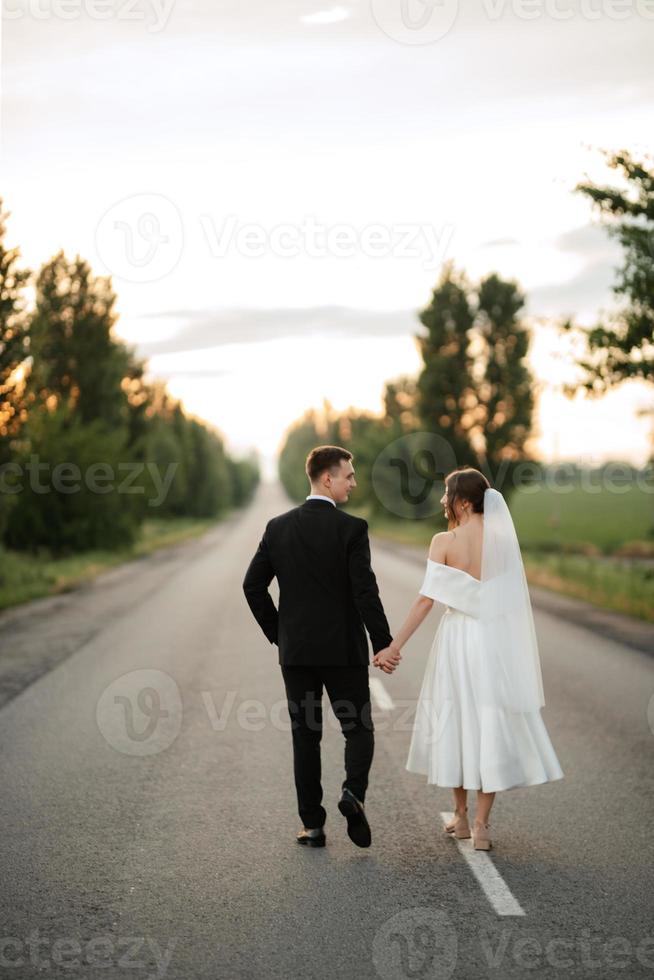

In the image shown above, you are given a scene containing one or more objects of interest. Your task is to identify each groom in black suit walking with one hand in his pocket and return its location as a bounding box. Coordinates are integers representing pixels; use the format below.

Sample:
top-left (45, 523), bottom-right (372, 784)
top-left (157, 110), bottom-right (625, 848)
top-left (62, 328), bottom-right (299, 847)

top-left (243, 446), bottom-right (400, 847)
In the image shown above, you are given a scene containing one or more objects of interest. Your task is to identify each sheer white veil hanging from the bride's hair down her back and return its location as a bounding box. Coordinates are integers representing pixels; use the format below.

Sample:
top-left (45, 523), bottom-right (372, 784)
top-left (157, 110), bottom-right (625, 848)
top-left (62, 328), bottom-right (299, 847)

top-left (479, 488), bottom-right (545, 711)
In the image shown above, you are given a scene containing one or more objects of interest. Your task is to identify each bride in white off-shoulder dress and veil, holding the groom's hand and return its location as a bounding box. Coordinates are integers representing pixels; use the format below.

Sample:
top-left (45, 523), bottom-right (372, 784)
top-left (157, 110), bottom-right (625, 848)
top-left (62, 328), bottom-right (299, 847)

top-left (372, 467), bottom-right (563, 850)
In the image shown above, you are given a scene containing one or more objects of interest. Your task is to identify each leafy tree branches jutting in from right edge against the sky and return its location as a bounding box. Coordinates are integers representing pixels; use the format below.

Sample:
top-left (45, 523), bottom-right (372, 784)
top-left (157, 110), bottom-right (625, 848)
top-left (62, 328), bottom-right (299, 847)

top-left (576, 151), bottom-right (654, 395)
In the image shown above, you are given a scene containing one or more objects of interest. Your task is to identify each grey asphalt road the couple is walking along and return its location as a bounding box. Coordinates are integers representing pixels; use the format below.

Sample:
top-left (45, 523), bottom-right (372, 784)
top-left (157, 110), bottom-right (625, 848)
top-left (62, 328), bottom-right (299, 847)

top-left (0, 487), bottom-right (654, 980)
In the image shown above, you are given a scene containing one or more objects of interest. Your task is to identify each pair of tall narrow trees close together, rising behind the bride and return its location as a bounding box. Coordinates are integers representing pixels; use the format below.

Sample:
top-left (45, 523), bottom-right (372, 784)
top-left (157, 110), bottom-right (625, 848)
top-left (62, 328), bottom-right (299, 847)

top-left (418, 265), bottom-right (534, 493)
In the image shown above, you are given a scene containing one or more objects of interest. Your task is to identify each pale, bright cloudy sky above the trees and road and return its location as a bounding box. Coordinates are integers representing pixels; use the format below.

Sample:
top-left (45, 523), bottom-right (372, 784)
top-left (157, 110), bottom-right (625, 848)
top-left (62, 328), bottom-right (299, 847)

top-left (0, 0), bottom-right (654, 470)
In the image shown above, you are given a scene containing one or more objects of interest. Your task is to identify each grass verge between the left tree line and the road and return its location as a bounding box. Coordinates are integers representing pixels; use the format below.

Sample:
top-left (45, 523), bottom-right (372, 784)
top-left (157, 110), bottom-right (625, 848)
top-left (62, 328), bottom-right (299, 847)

top-left (0, 518), bottom-right (223, 609)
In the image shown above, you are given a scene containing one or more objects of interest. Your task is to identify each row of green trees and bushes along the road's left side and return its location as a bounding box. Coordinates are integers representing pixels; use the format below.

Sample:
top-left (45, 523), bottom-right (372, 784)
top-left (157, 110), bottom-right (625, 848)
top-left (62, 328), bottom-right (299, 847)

top-left (0, 199), bottom-right (259, 555)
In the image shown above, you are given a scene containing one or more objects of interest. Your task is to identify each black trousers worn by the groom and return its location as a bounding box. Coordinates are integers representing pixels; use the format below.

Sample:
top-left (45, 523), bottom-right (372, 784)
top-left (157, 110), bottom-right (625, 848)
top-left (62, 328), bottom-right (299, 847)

top-left (282, 664), bottom-right (375, 829)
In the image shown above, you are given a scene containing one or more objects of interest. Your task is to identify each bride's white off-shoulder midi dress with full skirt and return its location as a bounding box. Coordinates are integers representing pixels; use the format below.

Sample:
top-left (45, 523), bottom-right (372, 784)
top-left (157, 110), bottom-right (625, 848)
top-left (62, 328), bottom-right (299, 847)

top-left (406, 562), bottom-right (563, 793)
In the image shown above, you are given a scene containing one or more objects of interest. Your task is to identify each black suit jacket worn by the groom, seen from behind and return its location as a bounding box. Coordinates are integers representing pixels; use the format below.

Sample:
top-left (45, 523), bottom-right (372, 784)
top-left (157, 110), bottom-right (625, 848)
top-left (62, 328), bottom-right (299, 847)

top-left (243, 500), bottom-right (392, 666)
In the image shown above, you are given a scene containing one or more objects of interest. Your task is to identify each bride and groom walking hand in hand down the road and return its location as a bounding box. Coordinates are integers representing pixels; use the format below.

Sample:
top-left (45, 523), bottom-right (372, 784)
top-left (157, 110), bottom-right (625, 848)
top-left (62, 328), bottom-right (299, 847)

top-left (243, 446), bottom-right (563, 850)
